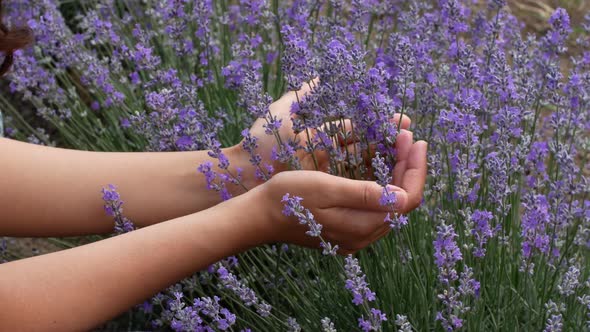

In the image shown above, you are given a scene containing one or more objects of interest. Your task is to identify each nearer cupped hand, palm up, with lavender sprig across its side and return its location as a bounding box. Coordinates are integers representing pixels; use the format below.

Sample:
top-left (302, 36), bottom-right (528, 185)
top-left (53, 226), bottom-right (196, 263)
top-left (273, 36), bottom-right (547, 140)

top-left (244, 136), bottom-right (427, 254)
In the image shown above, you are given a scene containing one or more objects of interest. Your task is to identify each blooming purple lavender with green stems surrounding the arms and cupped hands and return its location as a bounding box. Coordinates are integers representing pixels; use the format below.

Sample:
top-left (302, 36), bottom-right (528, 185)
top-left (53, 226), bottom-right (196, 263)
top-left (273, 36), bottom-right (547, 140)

top-left (0, 0), bottom-right (590, 331)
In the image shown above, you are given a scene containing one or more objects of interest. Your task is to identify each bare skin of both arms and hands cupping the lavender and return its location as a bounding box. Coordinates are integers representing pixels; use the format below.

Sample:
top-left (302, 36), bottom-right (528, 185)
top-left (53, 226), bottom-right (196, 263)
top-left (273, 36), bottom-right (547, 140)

top-left (0, 83), bottom-right (427, 331)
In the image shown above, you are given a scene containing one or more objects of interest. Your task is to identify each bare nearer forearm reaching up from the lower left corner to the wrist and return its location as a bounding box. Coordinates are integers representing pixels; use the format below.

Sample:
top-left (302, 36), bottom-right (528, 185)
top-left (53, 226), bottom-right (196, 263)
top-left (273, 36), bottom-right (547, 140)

top-left (0, 193), bottom-right (266, 331)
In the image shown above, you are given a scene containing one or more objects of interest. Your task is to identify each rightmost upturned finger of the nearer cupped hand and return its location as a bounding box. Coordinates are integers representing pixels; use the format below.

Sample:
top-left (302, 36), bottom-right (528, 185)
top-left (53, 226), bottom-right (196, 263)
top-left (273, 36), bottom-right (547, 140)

top-left (399, 141), bottom-right (428, 213)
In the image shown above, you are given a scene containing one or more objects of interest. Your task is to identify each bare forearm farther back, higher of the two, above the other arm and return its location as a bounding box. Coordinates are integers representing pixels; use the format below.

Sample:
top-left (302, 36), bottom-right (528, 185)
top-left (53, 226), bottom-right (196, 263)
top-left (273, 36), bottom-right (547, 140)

top-left (0, 139), bottom-right (252, 236)
